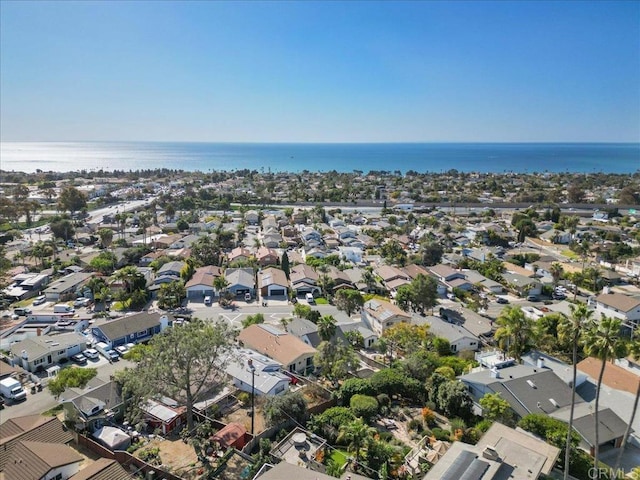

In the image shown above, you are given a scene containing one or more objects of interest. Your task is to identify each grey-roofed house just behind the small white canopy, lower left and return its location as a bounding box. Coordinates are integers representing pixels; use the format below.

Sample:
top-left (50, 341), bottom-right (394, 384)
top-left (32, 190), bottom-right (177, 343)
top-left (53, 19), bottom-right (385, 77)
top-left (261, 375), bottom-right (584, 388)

top-left (60, 379), bottom-right (124, 432)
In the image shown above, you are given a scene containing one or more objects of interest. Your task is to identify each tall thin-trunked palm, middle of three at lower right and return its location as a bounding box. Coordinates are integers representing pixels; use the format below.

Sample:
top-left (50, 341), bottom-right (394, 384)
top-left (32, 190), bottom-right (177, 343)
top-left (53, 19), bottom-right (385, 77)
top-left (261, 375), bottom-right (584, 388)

top-left (582, 315), bottom-right (626, 468)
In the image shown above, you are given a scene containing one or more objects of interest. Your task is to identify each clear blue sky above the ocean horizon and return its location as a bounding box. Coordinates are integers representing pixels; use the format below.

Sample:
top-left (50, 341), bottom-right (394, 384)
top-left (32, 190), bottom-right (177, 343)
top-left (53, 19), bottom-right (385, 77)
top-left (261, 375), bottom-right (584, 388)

top-left (0, 0), bottom-right (640, 142)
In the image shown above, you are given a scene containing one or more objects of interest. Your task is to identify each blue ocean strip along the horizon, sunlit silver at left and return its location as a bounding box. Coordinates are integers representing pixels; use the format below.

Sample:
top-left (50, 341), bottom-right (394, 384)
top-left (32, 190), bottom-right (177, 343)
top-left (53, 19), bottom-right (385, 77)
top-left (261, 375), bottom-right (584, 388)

top-left (0, 142), bottom-right (640, 173)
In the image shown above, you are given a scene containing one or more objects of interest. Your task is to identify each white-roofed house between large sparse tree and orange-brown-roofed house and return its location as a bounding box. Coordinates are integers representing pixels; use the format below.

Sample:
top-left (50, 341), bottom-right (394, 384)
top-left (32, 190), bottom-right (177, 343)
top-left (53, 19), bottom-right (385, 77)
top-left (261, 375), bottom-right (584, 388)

top-left (225, 348), bottom-right (291, 396)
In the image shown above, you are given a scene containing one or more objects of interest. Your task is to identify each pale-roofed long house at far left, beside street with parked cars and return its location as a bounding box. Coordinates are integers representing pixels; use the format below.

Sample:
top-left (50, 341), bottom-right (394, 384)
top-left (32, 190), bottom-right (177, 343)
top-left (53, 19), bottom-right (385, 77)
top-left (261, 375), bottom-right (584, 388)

top-left (11, 332), bottom-right (87, 372)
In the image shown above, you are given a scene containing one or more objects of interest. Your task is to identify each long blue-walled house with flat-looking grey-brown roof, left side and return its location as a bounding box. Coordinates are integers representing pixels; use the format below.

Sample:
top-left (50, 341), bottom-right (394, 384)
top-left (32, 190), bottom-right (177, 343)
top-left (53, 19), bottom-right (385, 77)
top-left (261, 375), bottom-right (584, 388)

top-left (91, 312), bottom-right (171, 348)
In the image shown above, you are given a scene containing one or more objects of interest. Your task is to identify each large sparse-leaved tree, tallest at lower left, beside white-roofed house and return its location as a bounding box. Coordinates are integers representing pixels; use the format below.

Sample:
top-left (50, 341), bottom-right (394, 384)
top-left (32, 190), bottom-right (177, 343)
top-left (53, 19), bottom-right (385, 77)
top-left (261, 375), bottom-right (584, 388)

top-left (117, 319), bottom-right (236, 431)
